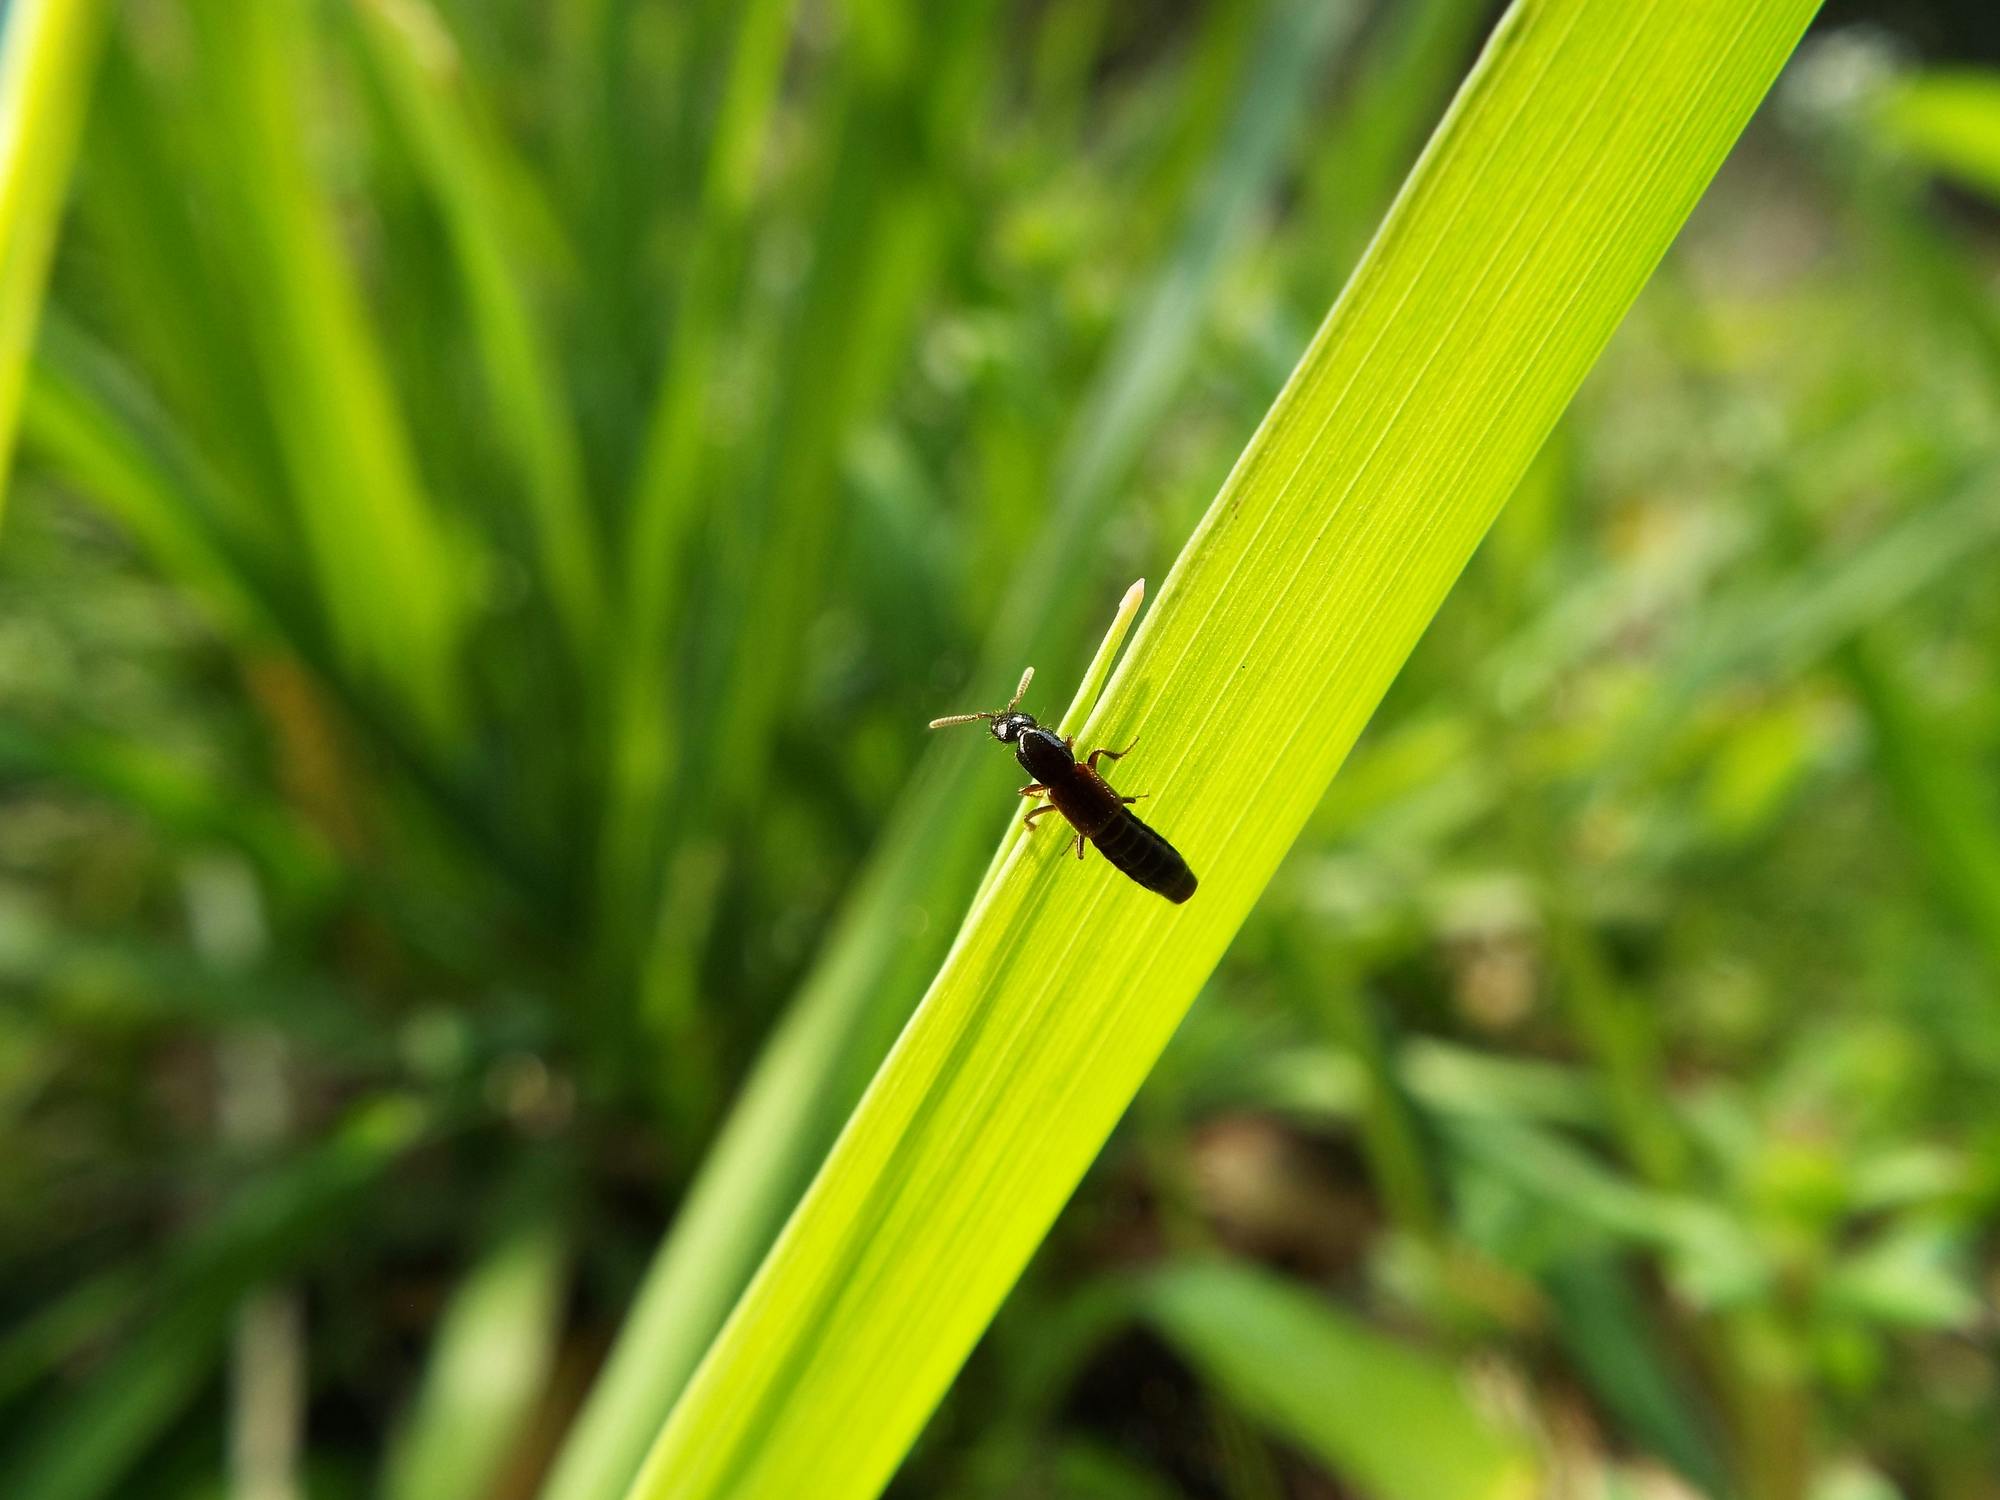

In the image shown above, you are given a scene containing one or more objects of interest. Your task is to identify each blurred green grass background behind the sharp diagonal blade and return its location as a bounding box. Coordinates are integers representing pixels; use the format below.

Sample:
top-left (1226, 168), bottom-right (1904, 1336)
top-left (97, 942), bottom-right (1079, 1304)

top-left (0, 0), bottom-right (2000, 1500)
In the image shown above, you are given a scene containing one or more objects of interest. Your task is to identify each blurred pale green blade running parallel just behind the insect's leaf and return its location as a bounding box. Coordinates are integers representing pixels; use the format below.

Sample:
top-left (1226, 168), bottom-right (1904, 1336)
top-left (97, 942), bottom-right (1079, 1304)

top-left (544, 11), bottom-right (1352, 1500)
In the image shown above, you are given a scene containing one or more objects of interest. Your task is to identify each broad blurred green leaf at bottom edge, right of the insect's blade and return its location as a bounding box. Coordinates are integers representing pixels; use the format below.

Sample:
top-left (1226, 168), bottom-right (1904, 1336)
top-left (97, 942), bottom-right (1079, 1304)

top-left (1140, 1262), bottom-right (1536, 1500)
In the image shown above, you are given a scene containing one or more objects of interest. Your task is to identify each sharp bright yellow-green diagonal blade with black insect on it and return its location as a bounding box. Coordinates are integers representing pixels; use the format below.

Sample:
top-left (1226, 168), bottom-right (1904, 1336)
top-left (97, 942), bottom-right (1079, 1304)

top-left (632, 0), bottom-right (1814, 1500)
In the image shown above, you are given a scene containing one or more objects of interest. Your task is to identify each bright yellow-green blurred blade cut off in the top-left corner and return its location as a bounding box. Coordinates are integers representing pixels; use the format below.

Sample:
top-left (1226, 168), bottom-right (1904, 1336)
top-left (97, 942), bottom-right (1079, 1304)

top-left (0, 0), bottom-right (106, 518)
